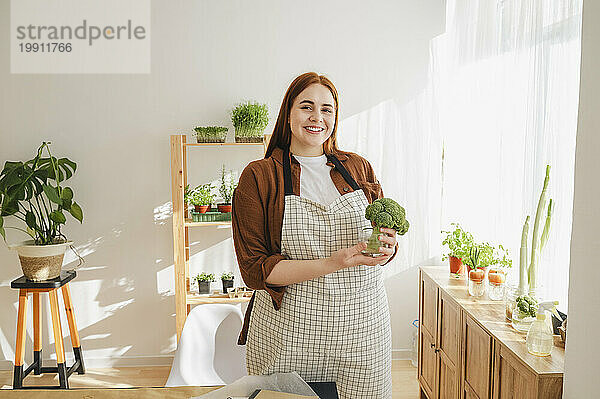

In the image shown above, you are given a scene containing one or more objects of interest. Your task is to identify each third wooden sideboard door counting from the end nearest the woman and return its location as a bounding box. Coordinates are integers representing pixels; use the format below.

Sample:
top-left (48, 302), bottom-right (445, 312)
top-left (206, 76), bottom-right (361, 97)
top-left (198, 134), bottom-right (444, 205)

top-left (463, 313), bottom-right (493, 399)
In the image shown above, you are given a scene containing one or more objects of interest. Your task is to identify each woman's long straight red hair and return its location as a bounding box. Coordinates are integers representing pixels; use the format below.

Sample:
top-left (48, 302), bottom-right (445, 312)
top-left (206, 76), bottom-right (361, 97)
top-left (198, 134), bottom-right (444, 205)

top-left (265, 72), bottom-right (338, 158)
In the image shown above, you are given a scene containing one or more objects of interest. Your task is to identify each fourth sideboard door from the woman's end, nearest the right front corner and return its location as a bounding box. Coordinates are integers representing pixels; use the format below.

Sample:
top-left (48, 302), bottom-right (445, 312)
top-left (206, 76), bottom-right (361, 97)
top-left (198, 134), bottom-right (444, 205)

top-left (494, 344), bottom-right (536, 399)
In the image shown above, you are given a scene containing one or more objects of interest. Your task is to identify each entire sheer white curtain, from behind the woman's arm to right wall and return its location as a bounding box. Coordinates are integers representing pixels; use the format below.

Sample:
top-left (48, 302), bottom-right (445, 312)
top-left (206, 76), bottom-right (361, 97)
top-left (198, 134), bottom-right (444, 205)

top-left (340, 0), bottom-right (582, 309)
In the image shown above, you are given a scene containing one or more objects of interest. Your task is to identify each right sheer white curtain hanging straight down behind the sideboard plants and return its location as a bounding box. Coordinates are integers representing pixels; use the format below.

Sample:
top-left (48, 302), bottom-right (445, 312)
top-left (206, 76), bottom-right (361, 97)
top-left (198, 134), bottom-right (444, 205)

top-left (433, 0), bottom-right (581, 309)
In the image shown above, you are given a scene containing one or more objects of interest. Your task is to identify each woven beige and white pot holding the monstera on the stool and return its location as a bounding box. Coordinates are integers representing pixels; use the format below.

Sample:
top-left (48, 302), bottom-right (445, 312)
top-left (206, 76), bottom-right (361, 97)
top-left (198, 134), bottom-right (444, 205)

top-left (9, 240), bottom-right (73, 281)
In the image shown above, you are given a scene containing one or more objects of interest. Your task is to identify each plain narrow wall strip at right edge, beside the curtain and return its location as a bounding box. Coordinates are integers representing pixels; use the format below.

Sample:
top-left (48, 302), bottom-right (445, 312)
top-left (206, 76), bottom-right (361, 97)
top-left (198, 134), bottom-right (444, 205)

top-left (564, 0), bottom-right (600, 399)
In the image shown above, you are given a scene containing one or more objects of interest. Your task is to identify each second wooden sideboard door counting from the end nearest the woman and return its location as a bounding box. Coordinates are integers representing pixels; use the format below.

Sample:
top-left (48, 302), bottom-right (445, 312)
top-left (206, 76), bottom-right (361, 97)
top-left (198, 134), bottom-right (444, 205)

top-left (437, 290), bottom-right (461, 399)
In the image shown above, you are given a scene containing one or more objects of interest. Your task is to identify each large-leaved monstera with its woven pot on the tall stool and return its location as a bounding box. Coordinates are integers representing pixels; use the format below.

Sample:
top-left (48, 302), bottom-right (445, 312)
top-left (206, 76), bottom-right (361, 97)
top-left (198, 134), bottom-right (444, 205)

top-left (0, 142), bottom-right (83, 281)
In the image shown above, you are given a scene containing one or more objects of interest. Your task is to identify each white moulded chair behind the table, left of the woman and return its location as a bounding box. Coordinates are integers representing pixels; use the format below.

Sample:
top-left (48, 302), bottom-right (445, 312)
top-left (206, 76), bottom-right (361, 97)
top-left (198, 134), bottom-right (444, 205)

top-left (165, 304), bottom-right (247, 387)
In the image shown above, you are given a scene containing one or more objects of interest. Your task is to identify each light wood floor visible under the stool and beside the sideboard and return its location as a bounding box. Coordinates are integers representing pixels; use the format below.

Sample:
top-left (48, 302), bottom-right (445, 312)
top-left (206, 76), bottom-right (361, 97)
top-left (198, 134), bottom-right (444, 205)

top-left (0, 360), bottom-right (419, 399)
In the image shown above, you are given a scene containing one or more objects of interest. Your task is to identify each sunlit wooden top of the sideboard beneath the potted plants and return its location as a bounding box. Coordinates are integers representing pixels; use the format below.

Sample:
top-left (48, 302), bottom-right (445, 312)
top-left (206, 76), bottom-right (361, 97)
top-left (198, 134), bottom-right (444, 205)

top-left (421, 266), bottom-right (565, 376)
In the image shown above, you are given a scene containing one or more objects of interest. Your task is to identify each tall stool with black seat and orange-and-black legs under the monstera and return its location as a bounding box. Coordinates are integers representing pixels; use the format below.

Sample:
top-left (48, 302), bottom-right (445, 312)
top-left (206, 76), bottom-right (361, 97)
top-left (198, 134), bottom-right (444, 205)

top-left (10, 270), bottom-right (85, 389)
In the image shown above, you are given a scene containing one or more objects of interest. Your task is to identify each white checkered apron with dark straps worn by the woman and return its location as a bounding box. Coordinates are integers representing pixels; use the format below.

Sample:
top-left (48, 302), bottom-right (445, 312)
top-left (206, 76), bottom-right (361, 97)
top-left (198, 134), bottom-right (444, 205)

top-left (246, 152), bottom-right (392, 399)
